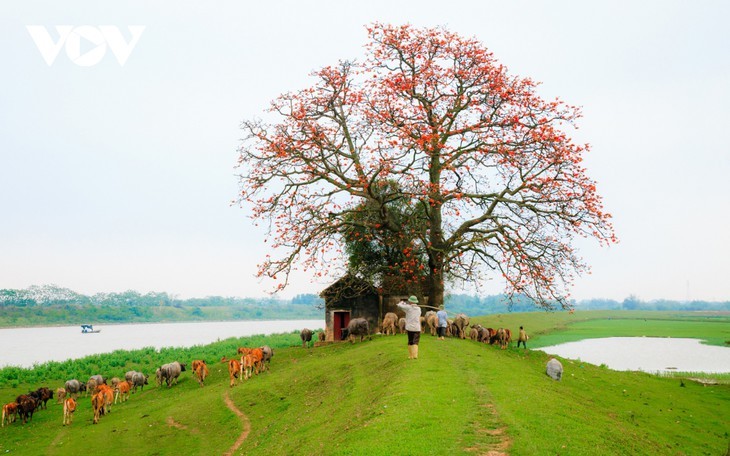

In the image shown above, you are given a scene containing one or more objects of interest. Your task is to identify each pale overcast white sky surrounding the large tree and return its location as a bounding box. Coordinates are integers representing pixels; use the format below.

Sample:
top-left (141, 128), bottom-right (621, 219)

top-left (0, 0), bottom-right (730, 301)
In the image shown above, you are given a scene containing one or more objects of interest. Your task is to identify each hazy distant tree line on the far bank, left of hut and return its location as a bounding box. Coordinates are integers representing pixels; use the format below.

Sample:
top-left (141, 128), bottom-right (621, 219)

top-left (0, 285), bottom-right (323, 326)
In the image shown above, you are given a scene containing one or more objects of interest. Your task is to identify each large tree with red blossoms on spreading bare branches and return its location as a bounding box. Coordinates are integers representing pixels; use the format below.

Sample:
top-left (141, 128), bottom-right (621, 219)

top-left (239, 24), bottom-right (615, 307)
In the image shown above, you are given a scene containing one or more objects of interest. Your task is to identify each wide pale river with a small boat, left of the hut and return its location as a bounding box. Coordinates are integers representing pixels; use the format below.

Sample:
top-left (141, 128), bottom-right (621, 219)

top-left (0, 320), bottom-right (324, 368)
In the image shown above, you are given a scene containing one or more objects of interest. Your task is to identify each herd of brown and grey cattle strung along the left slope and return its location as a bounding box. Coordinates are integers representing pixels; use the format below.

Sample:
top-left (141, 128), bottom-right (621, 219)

top-left (2, 345), bottom-right (274, 427)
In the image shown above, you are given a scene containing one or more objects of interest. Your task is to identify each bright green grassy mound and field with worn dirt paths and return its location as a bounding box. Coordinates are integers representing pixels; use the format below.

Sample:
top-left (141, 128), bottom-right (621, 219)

top-left (0, 312), bottom-right (730, 455)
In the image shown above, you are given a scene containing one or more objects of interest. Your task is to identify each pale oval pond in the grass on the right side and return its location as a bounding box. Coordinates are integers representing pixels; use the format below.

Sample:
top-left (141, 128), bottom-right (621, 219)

top-left (538, 337), bottom-right (730, 373)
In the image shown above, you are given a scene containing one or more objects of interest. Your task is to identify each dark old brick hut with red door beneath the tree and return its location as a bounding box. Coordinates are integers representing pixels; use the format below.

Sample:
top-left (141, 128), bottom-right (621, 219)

top-left (319, 275), bottom-right (426, 342)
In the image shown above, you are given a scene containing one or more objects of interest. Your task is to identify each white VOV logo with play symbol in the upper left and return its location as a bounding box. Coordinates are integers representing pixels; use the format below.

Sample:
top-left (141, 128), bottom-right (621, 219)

top-left (25, 25), bottom-right (145, 67)
